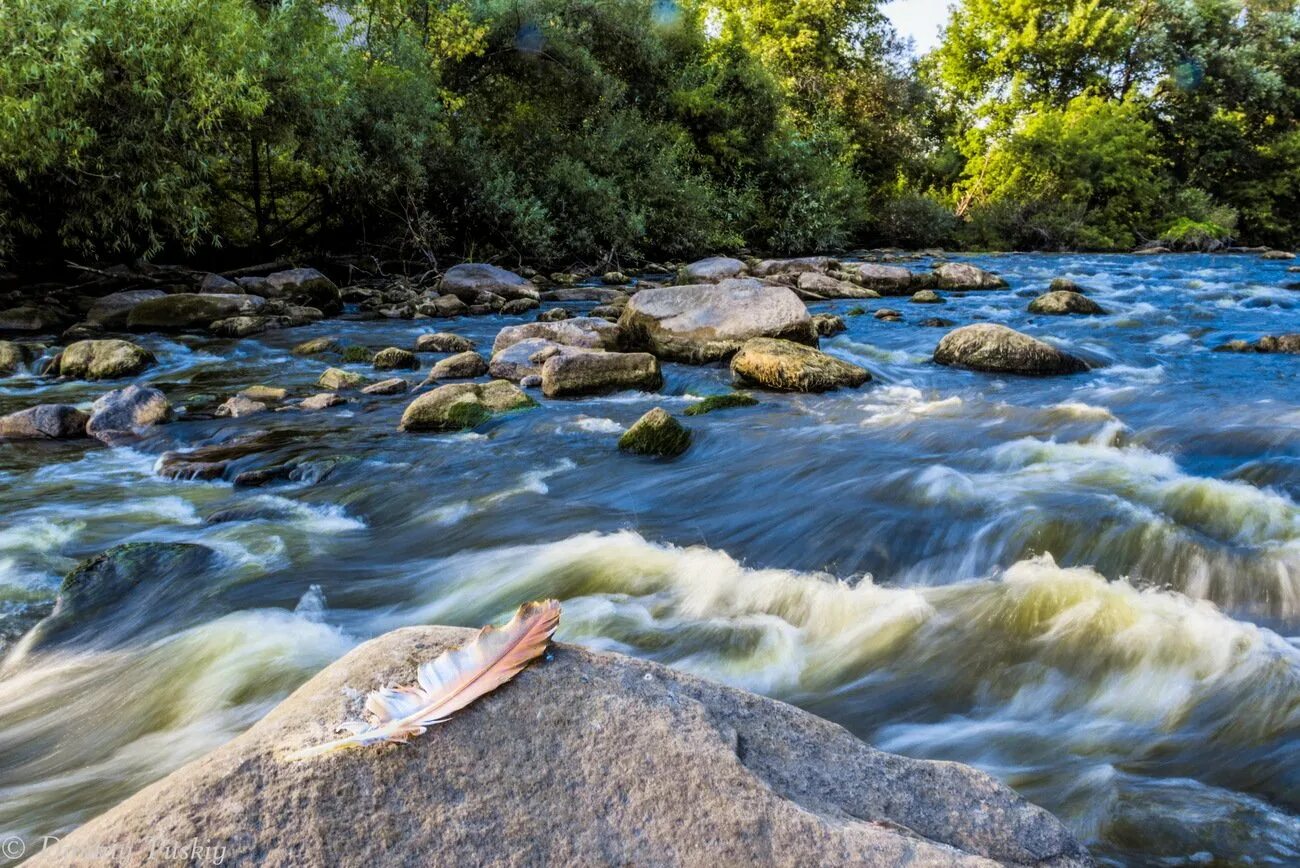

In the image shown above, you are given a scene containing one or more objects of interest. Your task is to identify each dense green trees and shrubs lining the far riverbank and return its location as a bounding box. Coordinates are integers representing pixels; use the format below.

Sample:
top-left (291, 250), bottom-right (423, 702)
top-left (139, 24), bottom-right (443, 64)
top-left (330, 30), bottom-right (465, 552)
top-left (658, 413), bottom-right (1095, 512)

top-left (0, 0), bottom-right (1300, 270)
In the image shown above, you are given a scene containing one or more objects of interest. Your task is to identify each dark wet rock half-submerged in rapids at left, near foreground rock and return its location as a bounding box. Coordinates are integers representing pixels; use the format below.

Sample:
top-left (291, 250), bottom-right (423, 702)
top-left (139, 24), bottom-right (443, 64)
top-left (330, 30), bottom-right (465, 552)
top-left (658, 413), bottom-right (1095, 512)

top-left (22, 542), bottom-right (218, 647)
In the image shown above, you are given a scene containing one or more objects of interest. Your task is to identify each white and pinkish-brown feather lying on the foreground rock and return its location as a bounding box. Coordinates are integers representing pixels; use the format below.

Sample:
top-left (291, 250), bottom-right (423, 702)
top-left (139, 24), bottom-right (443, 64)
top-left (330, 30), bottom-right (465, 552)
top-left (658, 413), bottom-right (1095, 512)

top-left (289, 600), bottom-right (560, 760)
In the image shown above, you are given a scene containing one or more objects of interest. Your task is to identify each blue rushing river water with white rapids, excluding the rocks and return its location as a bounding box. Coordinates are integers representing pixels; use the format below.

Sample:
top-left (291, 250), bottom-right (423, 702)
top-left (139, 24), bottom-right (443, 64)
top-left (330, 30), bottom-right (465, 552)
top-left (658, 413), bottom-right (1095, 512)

top-left (0, 256), bottom-right (1300, 864)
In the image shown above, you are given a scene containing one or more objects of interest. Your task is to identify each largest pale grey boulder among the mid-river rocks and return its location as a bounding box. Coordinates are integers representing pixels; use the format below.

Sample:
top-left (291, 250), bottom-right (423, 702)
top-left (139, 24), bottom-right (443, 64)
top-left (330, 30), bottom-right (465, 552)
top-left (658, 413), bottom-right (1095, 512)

top-left (619, 279), bottom-right (818, 364)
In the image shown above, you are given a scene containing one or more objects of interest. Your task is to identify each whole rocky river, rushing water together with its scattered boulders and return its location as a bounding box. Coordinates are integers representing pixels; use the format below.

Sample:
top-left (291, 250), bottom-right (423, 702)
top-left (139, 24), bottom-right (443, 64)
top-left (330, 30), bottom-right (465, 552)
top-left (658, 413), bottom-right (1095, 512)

top-left (0, 249), bottom-right (1300, 864)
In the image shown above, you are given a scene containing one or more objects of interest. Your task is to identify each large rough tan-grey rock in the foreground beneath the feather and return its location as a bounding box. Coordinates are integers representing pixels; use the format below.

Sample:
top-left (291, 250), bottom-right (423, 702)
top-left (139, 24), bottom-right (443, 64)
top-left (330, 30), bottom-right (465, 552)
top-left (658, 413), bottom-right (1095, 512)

top-left (29, 628), bottom-right (1091, 868)
